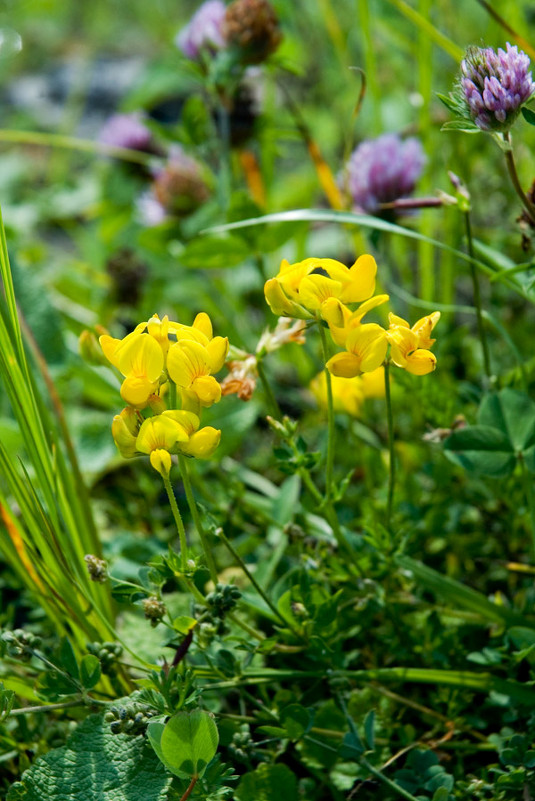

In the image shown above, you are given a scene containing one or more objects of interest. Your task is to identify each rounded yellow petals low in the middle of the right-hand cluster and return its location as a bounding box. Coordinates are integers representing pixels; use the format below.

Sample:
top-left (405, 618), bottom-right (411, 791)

top-left (326, 323), bottom-right (388, 378)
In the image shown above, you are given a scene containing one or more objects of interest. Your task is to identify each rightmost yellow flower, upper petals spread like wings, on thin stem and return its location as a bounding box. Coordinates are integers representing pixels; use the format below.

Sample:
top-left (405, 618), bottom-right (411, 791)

top-left (387, 312), bottom-right (440, 375)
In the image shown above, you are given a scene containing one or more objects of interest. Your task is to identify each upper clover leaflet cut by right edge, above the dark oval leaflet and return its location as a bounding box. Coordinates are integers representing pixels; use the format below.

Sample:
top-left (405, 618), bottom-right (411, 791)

top-left (478, 388), bottom-right (535, 453)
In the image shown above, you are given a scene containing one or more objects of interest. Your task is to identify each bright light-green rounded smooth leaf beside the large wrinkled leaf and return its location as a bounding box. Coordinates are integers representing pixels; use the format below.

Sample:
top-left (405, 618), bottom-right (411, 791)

top-left (160, 709), bottom-right (219, 779)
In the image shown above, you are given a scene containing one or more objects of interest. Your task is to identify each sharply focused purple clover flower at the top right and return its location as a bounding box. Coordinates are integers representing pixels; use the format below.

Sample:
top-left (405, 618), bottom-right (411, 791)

top-left (460, 42), bottom-right (535, 131)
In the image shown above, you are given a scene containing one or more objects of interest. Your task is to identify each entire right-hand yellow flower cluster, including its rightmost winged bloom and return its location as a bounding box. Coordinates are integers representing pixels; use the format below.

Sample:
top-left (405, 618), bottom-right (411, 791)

top-left (264, 255), bottom-right (440, 378)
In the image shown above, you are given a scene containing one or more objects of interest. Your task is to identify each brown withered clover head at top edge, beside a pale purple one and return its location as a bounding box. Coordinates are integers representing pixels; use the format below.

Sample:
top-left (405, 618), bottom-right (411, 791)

top-left (223, 0), bottom-right (282, 64)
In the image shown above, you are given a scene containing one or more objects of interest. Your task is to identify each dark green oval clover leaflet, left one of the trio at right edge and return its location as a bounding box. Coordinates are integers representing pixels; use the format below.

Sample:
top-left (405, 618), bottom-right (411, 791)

top-left (444, 425), bottom-right (516, 478)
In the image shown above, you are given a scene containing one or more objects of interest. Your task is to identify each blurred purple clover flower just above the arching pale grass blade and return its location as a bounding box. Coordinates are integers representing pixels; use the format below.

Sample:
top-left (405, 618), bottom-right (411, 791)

top-left (346, 134), bottom-right (426, 214)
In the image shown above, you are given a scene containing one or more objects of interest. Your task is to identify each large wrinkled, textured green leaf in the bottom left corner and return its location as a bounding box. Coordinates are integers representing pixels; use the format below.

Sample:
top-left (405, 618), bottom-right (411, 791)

top-left (7, 715), bottom-right (169, 801)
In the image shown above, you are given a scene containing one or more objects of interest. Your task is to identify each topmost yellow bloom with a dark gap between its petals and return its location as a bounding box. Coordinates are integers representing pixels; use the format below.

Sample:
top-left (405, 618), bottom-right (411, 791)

top-left (264, 255), bottom-right (377, 320)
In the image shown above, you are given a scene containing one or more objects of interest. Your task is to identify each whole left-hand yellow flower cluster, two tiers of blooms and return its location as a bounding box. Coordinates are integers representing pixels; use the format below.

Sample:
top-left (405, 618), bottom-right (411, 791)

top-left (100, 312), bottom-right (229, 475)
